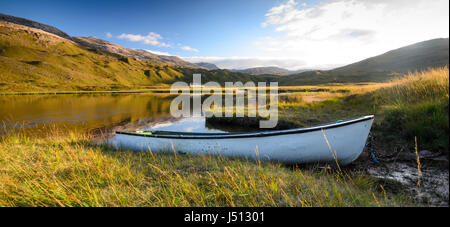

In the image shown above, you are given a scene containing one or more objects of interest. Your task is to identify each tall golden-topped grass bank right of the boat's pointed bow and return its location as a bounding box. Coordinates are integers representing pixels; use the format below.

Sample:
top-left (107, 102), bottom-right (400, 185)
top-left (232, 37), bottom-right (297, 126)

top-left (374, 67), bottom-right (449, 152)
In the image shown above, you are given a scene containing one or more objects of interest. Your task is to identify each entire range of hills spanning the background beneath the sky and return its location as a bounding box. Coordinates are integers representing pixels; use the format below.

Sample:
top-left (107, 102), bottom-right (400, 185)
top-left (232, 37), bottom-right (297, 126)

top-left (0, 14), bottom-right (449, 92)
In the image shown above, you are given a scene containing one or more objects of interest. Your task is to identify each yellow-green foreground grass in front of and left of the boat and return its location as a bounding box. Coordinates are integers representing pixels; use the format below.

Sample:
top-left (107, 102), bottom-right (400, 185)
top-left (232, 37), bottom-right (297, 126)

top-left (0, 129), bottom-right (412, 206)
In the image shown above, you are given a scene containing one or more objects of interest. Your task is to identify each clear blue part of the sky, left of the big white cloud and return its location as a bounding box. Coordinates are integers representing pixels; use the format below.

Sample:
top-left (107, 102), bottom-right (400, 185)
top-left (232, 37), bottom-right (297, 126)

top-left (0, 0), bottom-right (296, 57)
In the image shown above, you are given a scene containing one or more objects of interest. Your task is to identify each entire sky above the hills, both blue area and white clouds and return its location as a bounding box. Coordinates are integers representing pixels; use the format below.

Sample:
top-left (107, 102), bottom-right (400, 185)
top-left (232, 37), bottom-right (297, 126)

top-left (0, 0), bottom-right (449, 69)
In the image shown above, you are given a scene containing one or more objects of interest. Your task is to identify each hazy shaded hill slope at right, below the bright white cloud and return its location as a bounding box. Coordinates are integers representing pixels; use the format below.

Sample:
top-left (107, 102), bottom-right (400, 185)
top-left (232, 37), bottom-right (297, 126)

top-left (280, 38), bottom-right (449, 85)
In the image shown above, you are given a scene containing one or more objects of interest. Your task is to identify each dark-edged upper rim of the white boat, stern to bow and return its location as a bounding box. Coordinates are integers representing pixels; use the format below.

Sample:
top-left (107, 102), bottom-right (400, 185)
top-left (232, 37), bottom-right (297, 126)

top-left (116, 115), bottom-right (375, 139)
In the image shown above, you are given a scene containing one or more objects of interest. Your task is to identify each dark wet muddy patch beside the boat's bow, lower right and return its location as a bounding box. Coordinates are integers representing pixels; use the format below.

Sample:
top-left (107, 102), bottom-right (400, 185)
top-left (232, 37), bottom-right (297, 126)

top-left (354, 145), bottom-right (449, 207)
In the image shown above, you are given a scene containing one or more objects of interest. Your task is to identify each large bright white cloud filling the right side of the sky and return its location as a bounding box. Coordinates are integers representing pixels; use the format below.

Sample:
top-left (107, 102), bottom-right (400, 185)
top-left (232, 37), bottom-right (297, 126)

top-left (254, 0), bottom-right (449, 67)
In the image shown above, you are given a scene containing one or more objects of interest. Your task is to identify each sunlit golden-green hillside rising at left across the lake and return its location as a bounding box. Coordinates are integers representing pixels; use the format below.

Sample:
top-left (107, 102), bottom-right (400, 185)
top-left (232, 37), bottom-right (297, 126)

top-left (0, 21), bottom-right (264, 92)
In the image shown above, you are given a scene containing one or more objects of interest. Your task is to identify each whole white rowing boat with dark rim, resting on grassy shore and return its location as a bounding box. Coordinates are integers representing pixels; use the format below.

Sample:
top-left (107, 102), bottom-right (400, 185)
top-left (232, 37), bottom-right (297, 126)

top-left (108, 116), bottom-right (374, 165)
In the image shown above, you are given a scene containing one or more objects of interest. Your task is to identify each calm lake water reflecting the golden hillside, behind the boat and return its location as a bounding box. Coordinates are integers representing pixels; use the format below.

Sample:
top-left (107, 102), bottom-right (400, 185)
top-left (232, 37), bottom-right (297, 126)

top-left (0, 94), bottom-right (230, 132)
